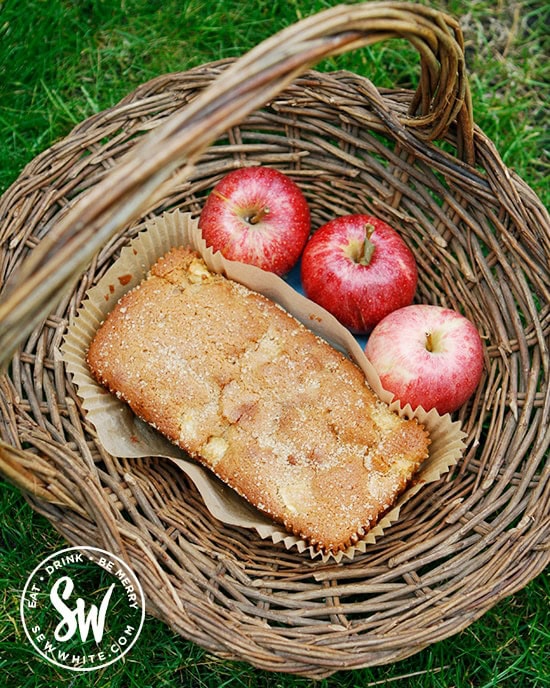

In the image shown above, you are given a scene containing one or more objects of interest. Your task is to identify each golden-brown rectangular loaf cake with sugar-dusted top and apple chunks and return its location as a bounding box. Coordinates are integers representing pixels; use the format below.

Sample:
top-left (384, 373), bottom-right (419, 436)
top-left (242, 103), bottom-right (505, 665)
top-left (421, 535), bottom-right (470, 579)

top-left (87, 248), bottom-right (429, 553)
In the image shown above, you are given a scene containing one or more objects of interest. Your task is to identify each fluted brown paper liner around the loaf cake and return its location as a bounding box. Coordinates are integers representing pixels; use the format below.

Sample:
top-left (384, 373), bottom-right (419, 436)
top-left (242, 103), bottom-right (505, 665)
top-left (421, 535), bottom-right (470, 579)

top-left (61, 210), bottom-right (465, 561)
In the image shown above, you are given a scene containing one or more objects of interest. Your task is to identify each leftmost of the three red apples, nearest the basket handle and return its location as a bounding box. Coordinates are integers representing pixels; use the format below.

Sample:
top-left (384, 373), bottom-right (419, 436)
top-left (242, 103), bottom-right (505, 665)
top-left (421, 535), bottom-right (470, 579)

top-left (199, 167), bottom-right (311, 275)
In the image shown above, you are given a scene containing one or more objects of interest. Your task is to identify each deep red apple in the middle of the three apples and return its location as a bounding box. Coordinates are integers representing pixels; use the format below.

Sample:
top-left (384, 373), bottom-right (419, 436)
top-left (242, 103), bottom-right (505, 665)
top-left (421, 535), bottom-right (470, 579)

top-left (301, 215), bottom-right (418, 334)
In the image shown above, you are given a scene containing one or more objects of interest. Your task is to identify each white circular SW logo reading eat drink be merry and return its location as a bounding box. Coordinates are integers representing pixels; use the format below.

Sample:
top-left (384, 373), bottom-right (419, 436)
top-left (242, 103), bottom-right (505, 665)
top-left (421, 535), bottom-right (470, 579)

top-left (20, 547), bottom-right (145, 671)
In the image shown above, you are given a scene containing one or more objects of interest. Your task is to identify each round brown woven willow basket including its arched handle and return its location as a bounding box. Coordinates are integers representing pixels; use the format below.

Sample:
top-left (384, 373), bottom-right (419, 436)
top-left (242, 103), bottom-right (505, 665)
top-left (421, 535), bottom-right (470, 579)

top-left (0, 2), bottom-right (550, 677)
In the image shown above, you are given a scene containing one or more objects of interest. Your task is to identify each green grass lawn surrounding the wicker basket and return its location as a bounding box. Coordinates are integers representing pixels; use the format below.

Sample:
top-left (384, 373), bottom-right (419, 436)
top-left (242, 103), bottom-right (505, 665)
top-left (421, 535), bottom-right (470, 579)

top-left (0, 0), bottom-right (550, 688)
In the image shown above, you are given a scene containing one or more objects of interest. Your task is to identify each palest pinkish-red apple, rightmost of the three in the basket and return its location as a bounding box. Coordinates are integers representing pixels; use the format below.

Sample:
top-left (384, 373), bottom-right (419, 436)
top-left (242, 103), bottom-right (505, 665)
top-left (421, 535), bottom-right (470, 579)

top-left (365, 304), bottom-right (483, 414)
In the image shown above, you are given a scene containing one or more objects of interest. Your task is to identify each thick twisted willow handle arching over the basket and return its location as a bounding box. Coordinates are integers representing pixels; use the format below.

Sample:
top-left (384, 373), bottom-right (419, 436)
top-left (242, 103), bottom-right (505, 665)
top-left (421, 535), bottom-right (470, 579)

top-left (0, 2), bottom-right (473, 366)
